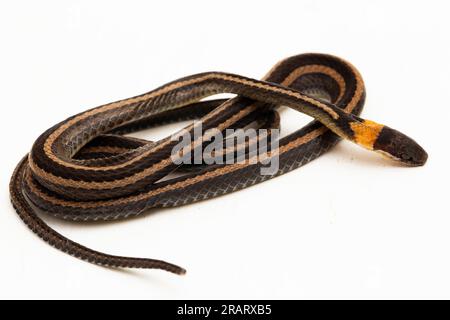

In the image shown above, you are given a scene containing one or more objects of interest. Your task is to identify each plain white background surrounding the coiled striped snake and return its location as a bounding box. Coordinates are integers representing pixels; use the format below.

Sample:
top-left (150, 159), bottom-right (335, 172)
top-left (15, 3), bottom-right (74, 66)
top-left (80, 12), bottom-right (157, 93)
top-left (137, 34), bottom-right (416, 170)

top-left (0, 0), bottom-right (450, 299)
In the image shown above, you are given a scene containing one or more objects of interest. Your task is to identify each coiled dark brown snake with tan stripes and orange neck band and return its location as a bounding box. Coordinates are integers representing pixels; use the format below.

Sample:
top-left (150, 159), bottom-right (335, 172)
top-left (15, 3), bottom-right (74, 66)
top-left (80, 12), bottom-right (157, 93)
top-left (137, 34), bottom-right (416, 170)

top-left (9, 53), bottom-right (428, 275)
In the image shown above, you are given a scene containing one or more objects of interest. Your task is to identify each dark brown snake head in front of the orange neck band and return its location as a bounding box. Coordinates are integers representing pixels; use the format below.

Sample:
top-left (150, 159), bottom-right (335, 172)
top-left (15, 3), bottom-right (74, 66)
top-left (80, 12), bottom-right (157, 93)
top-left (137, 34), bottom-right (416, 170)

top-left (373, 126), bottom-right (428, 167)
